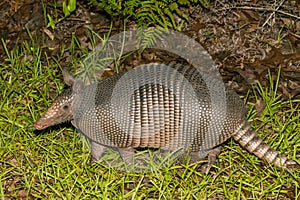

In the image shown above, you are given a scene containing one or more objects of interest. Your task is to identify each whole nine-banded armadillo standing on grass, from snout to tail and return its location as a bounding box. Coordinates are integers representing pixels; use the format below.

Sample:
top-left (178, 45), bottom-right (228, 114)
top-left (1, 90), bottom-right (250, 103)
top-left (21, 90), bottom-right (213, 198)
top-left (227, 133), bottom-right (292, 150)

top-left (34, 63), bottom-right (299, 169)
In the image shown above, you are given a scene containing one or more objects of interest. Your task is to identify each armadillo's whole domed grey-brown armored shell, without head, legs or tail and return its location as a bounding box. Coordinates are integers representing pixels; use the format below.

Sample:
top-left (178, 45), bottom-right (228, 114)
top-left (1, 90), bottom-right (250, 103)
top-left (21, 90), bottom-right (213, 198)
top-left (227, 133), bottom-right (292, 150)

top-left (73, 64), bottom-right (245, 156)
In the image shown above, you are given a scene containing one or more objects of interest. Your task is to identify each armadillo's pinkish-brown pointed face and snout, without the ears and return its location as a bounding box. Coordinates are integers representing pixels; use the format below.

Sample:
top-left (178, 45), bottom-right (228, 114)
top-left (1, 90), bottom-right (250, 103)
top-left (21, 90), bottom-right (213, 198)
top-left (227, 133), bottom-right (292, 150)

top-left (33, 88), bottom-right (74, 130)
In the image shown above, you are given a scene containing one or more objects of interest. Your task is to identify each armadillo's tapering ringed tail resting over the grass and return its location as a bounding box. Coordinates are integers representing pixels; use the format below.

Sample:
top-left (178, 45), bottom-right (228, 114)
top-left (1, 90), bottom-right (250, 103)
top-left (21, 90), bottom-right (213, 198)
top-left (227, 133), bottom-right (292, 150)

top-left (233, 120), bottom-right (300, 170)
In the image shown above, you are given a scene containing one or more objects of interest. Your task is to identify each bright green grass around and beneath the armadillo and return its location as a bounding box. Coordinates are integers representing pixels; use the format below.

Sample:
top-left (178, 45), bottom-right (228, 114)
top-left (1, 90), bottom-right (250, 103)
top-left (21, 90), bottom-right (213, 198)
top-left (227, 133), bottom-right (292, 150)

top-left (0, 37), bottom-right (300, 199)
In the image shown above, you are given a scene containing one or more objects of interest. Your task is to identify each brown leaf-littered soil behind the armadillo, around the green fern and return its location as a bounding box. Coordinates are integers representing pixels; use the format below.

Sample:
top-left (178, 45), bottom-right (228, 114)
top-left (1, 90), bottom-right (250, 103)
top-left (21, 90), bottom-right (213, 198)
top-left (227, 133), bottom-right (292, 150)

top-left (0, 0), bottom-right (300, 99)
